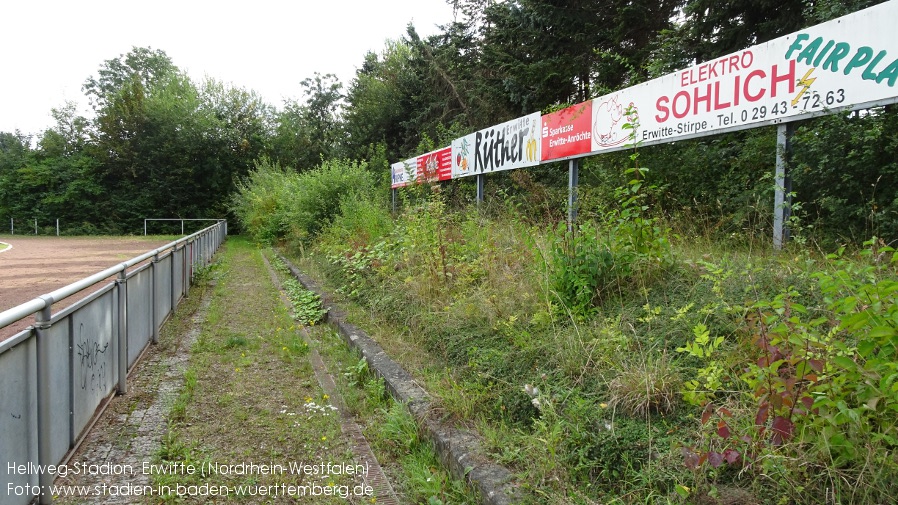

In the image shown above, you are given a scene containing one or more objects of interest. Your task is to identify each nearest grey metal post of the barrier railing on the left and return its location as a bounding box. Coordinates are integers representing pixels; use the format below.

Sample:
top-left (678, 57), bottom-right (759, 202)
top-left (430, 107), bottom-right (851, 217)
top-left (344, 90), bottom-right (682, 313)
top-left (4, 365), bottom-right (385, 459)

top-left (34, 295), bottom-right (56, 505)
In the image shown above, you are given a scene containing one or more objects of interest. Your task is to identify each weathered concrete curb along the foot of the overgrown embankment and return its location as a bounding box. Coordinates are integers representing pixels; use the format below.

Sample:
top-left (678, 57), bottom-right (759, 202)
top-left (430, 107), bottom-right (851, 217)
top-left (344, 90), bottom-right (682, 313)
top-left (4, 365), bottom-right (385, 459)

top-left (275, 252), bottom-right (522, 505)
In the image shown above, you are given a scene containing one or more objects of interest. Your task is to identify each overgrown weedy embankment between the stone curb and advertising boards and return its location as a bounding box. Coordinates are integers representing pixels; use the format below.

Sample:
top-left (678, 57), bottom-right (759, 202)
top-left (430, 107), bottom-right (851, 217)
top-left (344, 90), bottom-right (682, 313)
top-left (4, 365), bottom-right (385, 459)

top-left (236, 160), bottom-right (898, 505)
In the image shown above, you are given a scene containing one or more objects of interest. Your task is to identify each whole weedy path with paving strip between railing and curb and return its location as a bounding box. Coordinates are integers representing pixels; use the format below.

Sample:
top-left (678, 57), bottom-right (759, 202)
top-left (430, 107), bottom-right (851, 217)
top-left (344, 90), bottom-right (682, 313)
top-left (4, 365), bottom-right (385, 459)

top-left (50, 238), bottom-right (390, 504)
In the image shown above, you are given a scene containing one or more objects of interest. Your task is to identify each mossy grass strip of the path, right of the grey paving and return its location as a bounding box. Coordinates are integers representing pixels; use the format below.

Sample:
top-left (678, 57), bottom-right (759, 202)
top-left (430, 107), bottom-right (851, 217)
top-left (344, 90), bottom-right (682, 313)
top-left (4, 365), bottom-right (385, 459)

top-left (153, 237), bottom-right (362, 503)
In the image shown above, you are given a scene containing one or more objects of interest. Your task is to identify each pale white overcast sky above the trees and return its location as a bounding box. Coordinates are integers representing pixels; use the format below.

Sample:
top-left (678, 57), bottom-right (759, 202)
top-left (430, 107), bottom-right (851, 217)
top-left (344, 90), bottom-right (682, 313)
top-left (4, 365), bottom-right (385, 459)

top-left (0, 0), bottom-right (452, 133)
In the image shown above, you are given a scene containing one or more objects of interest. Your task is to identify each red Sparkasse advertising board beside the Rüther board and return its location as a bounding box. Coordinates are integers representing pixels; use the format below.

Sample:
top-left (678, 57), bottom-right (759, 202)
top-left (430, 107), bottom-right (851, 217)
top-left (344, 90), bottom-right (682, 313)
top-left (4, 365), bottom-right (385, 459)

top-left (540, 102), bottom-right (592, 161)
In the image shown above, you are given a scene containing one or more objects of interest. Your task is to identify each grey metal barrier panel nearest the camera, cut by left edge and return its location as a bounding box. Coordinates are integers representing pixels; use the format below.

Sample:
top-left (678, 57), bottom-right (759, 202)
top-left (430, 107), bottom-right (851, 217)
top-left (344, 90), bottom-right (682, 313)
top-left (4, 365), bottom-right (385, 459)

top-left (0, 330), bottom-right (38, 505)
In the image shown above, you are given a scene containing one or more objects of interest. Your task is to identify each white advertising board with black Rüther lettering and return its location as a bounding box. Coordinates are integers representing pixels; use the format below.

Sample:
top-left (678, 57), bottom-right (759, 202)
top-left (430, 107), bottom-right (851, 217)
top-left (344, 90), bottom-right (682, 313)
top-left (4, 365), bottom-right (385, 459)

top-left (452, 112), bottom-right (540, 179)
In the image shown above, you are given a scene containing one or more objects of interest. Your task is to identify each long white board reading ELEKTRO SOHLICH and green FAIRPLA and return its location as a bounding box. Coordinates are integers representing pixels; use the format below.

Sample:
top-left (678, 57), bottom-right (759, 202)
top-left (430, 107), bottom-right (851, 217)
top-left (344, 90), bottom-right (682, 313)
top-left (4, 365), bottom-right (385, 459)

top-left (592, 0), bottom-right (898, 153)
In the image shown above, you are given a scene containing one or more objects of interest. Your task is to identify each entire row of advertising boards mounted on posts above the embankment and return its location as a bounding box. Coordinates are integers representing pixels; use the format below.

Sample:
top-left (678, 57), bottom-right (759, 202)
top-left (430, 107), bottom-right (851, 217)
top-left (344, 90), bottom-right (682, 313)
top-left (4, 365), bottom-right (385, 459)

top-left (393, 0), bottom-right (898, 181)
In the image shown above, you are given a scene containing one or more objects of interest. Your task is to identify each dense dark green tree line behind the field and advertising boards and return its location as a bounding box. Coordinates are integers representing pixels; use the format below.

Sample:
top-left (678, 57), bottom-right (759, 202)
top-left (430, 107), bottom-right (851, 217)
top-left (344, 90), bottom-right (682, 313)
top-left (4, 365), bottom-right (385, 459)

top-left (0, 0), bottom-right (898, 239)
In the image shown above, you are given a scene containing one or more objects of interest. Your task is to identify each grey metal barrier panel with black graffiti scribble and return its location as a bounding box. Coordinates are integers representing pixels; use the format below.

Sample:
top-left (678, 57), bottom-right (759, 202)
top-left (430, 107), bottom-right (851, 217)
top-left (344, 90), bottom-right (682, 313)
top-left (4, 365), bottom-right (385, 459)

top-left (71, 287), bottom-right (118, 436)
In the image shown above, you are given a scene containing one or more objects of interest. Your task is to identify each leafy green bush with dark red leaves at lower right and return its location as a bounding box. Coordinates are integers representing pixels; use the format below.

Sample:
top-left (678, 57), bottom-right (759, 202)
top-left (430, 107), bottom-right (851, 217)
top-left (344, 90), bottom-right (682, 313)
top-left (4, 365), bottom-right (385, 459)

top-left (679, 239), bottom-right (898, 504)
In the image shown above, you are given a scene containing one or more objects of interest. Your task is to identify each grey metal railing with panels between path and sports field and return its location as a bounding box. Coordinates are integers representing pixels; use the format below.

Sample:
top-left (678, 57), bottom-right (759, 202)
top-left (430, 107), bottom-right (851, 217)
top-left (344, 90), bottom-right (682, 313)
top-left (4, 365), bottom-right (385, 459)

top-left (0, 221), bottom-right (227, 505)
